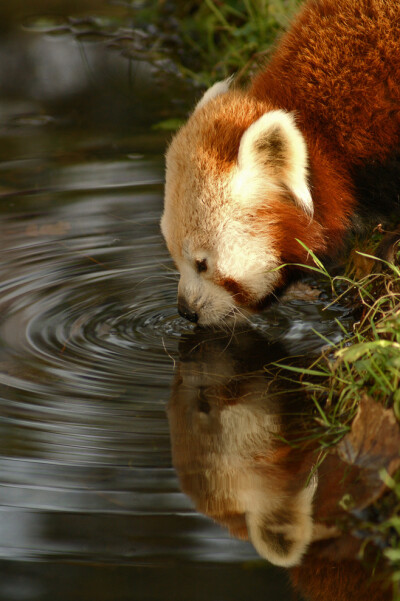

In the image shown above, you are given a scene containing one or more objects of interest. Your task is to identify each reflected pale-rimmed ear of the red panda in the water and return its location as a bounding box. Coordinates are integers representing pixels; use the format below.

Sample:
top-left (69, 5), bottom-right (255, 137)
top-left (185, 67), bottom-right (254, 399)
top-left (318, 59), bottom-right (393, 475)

top-left (246, 482), bottom-right (316, 568)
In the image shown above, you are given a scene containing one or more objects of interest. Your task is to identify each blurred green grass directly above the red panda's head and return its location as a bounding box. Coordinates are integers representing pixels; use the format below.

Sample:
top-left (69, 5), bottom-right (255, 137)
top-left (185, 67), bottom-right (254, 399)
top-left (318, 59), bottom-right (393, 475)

top-left (157, 0), bottom-right (300, 86)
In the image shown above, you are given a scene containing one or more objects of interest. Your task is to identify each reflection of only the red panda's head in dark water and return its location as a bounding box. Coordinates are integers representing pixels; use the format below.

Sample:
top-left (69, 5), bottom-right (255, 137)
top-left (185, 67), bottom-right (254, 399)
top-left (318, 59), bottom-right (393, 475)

top-left (169, 332), bottom-right (316, 566)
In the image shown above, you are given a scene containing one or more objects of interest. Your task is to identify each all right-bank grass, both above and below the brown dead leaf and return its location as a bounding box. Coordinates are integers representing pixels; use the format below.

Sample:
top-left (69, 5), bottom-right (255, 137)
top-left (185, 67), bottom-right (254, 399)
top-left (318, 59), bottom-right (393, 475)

top-left (276, 234), bottom-right (400, 601)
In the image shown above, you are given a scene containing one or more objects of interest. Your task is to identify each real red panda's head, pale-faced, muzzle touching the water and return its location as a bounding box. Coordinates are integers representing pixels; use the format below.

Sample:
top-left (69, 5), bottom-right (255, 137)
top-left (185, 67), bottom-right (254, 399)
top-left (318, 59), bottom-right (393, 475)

top-left (161, 82), bottom-right (322, 326)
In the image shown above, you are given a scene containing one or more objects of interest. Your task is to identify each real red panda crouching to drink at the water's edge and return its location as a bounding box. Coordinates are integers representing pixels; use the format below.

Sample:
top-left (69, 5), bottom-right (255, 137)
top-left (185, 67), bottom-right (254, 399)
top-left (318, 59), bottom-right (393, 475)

top-left (161, 0), bottom-right (400, 326)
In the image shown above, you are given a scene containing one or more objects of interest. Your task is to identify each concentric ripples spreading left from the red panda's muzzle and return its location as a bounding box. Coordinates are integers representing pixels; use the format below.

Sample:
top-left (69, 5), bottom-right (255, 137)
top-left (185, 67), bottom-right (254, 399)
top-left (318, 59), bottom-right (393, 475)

top-left (0, 190), bottom-right (191, 394)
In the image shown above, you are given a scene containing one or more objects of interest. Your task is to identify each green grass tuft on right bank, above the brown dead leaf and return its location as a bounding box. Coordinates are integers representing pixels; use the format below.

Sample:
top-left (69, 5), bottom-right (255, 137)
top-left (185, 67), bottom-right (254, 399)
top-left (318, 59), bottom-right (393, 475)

top-left (281, 237), bottom-right (400, 438)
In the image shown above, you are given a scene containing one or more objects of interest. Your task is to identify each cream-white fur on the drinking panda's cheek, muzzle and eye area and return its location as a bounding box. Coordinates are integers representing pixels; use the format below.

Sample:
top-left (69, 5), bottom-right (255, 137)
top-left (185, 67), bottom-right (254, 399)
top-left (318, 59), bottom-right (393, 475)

top-left (161, 169), bottom-right (280, 326)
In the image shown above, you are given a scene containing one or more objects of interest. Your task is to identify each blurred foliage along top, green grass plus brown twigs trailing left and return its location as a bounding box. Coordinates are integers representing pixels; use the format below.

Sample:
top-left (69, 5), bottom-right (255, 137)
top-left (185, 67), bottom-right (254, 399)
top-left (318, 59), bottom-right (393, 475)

top-left (22, 0), bottom-right (301, 86)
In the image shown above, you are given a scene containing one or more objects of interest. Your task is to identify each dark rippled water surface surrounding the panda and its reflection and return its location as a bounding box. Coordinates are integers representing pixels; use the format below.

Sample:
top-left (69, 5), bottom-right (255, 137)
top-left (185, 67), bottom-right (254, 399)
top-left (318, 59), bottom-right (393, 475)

top-left (0, 12), bottom-right (354, 601)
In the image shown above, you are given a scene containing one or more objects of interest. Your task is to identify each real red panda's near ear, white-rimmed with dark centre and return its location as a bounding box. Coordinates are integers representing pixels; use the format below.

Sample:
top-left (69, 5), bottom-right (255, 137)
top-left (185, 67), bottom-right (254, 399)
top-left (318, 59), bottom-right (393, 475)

top-left (237, 110), bottom-right (314, 215)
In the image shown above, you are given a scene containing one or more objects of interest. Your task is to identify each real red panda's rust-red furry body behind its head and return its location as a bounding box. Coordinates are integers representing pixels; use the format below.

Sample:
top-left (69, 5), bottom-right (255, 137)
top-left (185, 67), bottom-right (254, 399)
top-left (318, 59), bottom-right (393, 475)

top-left (250, 0), bottom-right (400, 255)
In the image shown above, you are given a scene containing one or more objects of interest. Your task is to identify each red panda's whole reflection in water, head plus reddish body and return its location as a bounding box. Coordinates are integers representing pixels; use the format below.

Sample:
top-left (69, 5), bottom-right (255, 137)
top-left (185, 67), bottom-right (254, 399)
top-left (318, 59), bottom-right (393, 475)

top-left (168, 331), bottom-right (390, 601)
